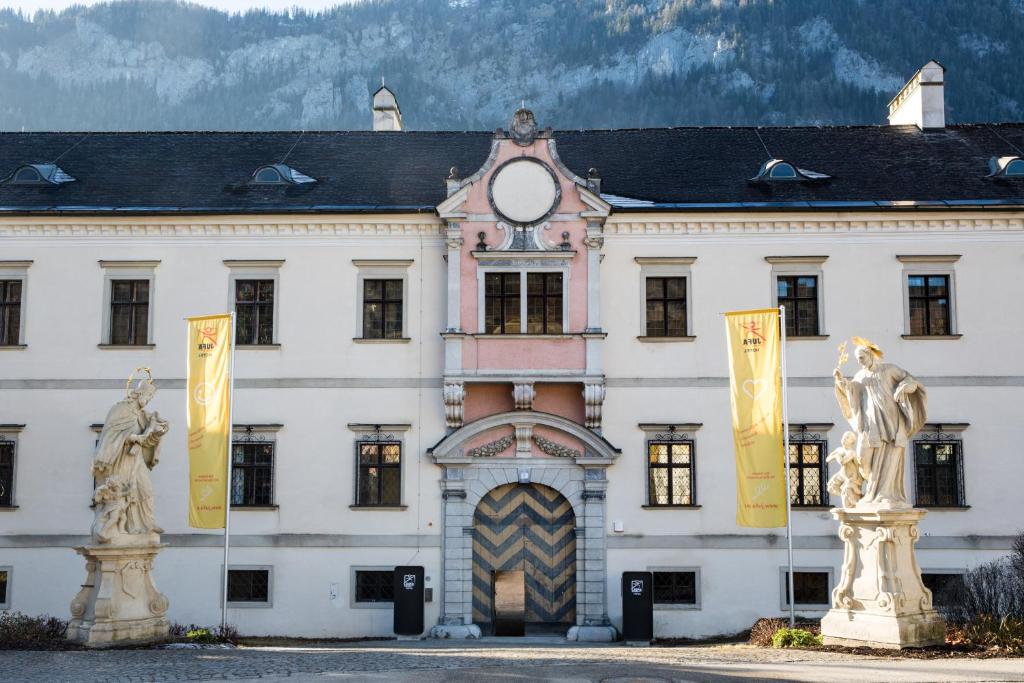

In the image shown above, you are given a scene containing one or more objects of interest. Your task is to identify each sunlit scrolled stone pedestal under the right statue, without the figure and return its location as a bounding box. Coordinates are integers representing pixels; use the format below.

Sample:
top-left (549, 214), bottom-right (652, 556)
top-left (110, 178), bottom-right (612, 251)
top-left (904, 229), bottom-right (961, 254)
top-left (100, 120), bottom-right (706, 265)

top-left (821, 508), bottom-right (946, 649)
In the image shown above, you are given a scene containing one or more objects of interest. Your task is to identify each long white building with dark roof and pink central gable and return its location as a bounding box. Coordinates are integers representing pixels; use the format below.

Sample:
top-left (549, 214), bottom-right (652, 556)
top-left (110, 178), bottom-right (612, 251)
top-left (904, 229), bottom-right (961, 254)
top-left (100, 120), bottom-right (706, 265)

top-left (0, 66), bottom-right (1024, 637)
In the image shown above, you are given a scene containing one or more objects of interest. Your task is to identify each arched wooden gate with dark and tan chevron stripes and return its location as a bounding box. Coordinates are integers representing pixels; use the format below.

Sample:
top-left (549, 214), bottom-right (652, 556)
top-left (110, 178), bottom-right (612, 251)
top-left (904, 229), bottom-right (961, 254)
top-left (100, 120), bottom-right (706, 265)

top-left (473, 483), bottom-right (577, 633)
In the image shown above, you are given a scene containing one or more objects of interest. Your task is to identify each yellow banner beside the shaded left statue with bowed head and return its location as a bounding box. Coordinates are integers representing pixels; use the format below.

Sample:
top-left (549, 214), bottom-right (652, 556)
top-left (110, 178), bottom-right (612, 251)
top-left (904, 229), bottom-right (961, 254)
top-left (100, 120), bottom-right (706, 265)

top-left (185, 313), bottom-right (233, 528)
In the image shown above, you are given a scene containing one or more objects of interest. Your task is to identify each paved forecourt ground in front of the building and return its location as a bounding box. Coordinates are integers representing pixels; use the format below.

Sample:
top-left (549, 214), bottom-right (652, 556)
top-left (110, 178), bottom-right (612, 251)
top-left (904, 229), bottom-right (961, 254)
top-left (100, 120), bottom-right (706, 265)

top-left (0, 639), bottom-right (1024, 683)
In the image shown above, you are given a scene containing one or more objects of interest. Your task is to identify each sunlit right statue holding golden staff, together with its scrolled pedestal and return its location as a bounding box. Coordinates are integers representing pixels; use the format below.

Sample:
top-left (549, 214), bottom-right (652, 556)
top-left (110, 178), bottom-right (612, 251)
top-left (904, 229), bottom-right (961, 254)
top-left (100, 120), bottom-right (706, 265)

top-left (821, 337), bottom-right (945, 649)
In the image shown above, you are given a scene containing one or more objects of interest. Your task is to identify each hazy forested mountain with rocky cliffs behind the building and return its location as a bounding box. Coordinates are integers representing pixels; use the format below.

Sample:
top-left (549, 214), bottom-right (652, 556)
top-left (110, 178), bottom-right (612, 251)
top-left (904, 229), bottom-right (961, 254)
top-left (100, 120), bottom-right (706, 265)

top-left (0, 0), bottom-right (1024, 130)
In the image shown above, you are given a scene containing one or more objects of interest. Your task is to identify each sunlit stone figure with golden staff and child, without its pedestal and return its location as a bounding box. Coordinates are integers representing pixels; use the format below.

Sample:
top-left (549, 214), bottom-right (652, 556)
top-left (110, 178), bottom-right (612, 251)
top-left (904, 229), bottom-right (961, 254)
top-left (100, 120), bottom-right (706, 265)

top-left (833, 337), bottom-right (928, 510)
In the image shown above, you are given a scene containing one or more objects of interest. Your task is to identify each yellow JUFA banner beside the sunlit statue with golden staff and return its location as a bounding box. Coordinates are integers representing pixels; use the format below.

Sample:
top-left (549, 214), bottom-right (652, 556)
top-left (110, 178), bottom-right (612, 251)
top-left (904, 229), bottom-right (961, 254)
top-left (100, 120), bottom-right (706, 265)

top-left (725, 308), bottom-right (788, 527)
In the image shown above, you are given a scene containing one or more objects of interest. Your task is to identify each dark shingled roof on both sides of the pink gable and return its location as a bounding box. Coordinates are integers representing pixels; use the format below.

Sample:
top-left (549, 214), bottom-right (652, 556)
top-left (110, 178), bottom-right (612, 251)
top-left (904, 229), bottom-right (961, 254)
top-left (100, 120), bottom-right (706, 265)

top-left (0, 124), bottom-right (1024, 214)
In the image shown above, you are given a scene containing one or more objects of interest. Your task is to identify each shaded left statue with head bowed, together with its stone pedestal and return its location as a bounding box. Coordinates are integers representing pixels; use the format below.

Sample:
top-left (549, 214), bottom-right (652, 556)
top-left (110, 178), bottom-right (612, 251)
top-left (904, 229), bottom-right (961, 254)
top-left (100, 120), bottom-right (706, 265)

top-left (67, 368), bottom-right (170, 647)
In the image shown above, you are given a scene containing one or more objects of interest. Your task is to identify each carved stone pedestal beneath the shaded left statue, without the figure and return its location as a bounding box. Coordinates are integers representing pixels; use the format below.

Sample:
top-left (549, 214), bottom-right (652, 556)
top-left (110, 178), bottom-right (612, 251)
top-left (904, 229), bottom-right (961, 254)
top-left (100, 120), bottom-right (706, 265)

top-left (67, 535), bottom-right (170, 647)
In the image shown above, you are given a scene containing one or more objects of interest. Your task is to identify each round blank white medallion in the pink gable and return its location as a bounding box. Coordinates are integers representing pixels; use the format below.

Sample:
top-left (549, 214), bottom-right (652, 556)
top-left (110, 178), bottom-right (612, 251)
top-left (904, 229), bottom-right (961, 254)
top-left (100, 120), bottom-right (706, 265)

top-left (490, 159), bottom-right (558, 223)
